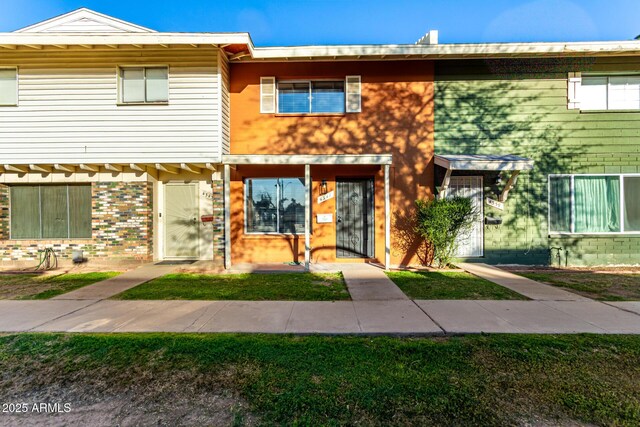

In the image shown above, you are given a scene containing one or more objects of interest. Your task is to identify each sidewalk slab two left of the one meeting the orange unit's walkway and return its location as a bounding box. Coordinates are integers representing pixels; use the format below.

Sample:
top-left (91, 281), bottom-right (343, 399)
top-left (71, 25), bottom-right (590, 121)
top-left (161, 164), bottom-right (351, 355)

top-left (198, 301), bottom-right (294, 333)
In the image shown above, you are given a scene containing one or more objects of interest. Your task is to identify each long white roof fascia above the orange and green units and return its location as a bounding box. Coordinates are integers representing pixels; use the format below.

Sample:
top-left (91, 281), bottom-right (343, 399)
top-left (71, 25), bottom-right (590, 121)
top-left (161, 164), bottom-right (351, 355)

top-left (240, 40), bottom-right (640, 60)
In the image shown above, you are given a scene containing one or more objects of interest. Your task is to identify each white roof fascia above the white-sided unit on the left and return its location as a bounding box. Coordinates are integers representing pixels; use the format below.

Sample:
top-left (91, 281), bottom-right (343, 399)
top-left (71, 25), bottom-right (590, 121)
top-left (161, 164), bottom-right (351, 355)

top-left (0, 32), bottom-right (253, 52)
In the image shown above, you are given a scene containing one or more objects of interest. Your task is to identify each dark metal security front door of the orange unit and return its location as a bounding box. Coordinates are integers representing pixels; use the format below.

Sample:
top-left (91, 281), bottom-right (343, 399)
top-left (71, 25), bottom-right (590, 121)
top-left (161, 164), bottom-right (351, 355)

top-left (336, 179), bottom-right (374, 258)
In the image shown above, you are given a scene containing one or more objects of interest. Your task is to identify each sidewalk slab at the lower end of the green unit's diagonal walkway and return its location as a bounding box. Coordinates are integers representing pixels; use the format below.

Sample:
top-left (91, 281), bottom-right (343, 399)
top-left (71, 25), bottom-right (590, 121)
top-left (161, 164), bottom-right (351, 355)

top-left (544, 301), bottom-right (640, 334)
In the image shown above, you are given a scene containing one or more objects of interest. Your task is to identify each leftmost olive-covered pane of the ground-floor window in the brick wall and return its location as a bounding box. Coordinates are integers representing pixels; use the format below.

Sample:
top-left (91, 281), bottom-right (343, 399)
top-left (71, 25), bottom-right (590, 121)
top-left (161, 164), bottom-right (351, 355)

top-left (10, 186), bottom-right (42, 239)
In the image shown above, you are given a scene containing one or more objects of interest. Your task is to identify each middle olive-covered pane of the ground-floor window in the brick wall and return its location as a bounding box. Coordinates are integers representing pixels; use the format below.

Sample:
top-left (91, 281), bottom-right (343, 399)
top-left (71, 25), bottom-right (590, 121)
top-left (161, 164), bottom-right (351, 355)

top-left (40, 185), bottom-right (69, 239)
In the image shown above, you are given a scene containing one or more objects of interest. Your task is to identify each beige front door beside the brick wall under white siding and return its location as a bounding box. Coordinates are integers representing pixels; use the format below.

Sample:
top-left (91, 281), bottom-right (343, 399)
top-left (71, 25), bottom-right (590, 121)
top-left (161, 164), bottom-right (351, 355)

top-left (164, 183), bottom-right (200, 259)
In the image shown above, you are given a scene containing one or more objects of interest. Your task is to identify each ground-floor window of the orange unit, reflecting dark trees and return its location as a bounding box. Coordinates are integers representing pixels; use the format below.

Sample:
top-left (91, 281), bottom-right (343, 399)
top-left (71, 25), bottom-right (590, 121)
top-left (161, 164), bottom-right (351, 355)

top-left (244, 178), bottom-right (305, 234)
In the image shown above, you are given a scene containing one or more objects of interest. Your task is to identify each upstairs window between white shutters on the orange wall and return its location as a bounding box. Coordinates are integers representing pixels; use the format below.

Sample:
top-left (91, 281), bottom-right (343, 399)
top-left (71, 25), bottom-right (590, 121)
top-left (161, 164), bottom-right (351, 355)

top-left (278, 81), bottom-right (345, 114)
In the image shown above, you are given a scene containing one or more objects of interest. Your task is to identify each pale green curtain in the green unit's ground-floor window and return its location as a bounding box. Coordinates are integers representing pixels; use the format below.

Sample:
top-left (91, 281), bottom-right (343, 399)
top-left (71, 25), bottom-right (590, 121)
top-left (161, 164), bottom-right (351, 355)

top-left (574, 176), bottom-right (620, 233)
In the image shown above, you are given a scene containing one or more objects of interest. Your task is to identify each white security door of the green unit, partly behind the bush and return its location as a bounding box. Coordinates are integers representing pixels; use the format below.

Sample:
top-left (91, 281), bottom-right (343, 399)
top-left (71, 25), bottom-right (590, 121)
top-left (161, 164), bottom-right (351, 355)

top-left (447, 176), bottom-right (484, 257)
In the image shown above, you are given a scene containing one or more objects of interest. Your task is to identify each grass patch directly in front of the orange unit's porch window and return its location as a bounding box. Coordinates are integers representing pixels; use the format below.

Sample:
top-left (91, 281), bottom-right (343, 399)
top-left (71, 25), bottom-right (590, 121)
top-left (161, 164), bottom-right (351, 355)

top-left (114, 273), bottom-right (350, 301)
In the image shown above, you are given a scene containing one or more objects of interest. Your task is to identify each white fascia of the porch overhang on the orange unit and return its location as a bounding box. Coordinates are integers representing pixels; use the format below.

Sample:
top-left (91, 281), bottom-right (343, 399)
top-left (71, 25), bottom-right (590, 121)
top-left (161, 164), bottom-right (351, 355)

top-left (222, 154), bottom-right (393, 165)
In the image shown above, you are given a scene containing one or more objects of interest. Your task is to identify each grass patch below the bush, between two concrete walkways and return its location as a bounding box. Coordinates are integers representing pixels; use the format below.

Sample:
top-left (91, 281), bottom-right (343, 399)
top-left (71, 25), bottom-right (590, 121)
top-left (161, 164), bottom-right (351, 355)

top-left (387, 271), bottom-right (527, 300)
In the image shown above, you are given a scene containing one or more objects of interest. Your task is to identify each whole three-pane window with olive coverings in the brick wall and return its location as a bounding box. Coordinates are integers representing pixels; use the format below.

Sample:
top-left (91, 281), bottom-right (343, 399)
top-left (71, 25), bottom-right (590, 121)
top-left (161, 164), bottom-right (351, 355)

top-left (9, 185), bottom-right (91, 240)
